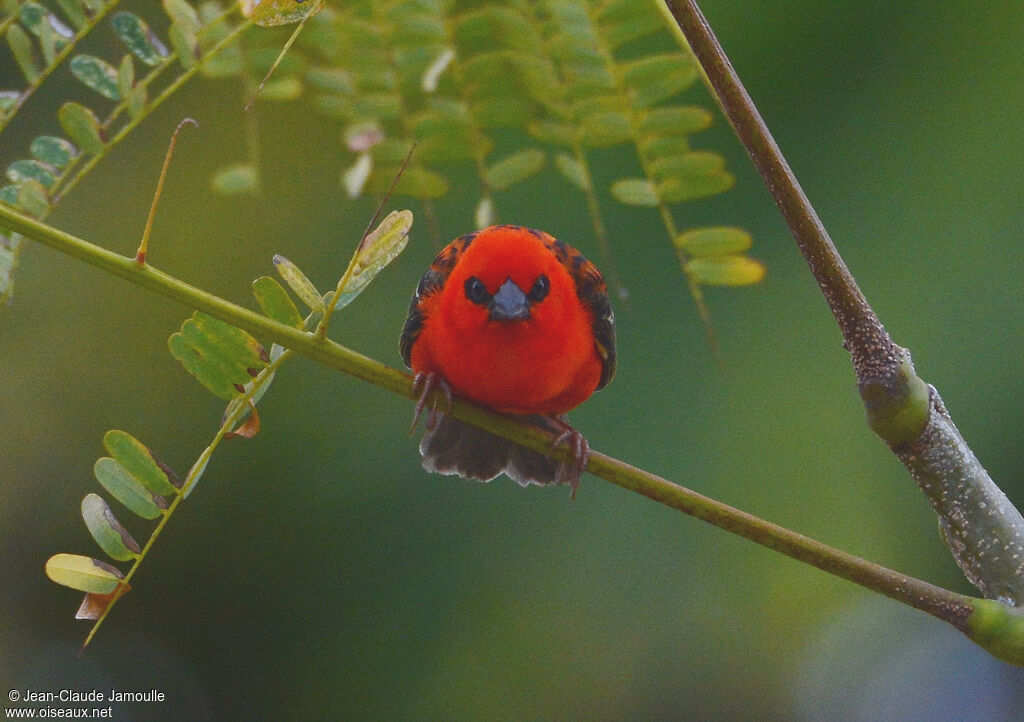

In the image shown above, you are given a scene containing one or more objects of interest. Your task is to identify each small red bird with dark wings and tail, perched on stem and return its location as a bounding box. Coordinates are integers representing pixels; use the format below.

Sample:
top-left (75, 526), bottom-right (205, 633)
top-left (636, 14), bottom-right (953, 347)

top-left (400, 225), bottom-right (615, 493)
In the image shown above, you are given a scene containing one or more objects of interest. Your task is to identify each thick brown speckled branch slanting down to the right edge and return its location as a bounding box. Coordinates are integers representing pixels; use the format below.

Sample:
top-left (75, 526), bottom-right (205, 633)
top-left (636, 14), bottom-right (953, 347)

top-left (658, 0), bottom-right (1024, 607)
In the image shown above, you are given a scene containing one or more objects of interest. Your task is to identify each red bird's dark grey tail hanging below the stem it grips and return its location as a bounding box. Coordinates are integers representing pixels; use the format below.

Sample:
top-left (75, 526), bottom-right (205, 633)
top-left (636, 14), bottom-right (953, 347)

top-left (420, 412), bottom-right (568, 486)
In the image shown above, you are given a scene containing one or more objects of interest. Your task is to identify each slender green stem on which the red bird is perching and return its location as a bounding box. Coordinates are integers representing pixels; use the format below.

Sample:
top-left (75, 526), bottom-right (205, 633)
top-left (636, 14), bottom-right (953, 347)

top-left (0, 199), bottom-right (1024, 665)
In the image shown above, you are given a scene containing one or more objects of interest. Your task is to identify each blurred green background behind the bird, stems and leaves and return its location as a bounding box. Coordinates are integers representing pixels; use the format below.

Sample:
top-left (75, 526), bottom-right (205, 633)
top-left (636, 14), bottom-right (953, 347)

top-left (0, 0), bottom-right (1024, 720)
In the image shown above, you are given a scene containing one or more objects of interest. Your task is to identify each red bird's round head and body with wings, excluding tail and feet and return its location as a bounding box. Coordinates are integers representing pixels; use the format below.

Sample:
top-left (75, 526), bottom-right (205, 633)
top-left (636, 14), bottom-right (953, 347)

top-left (400, 225), bottom-right (615, 416)
